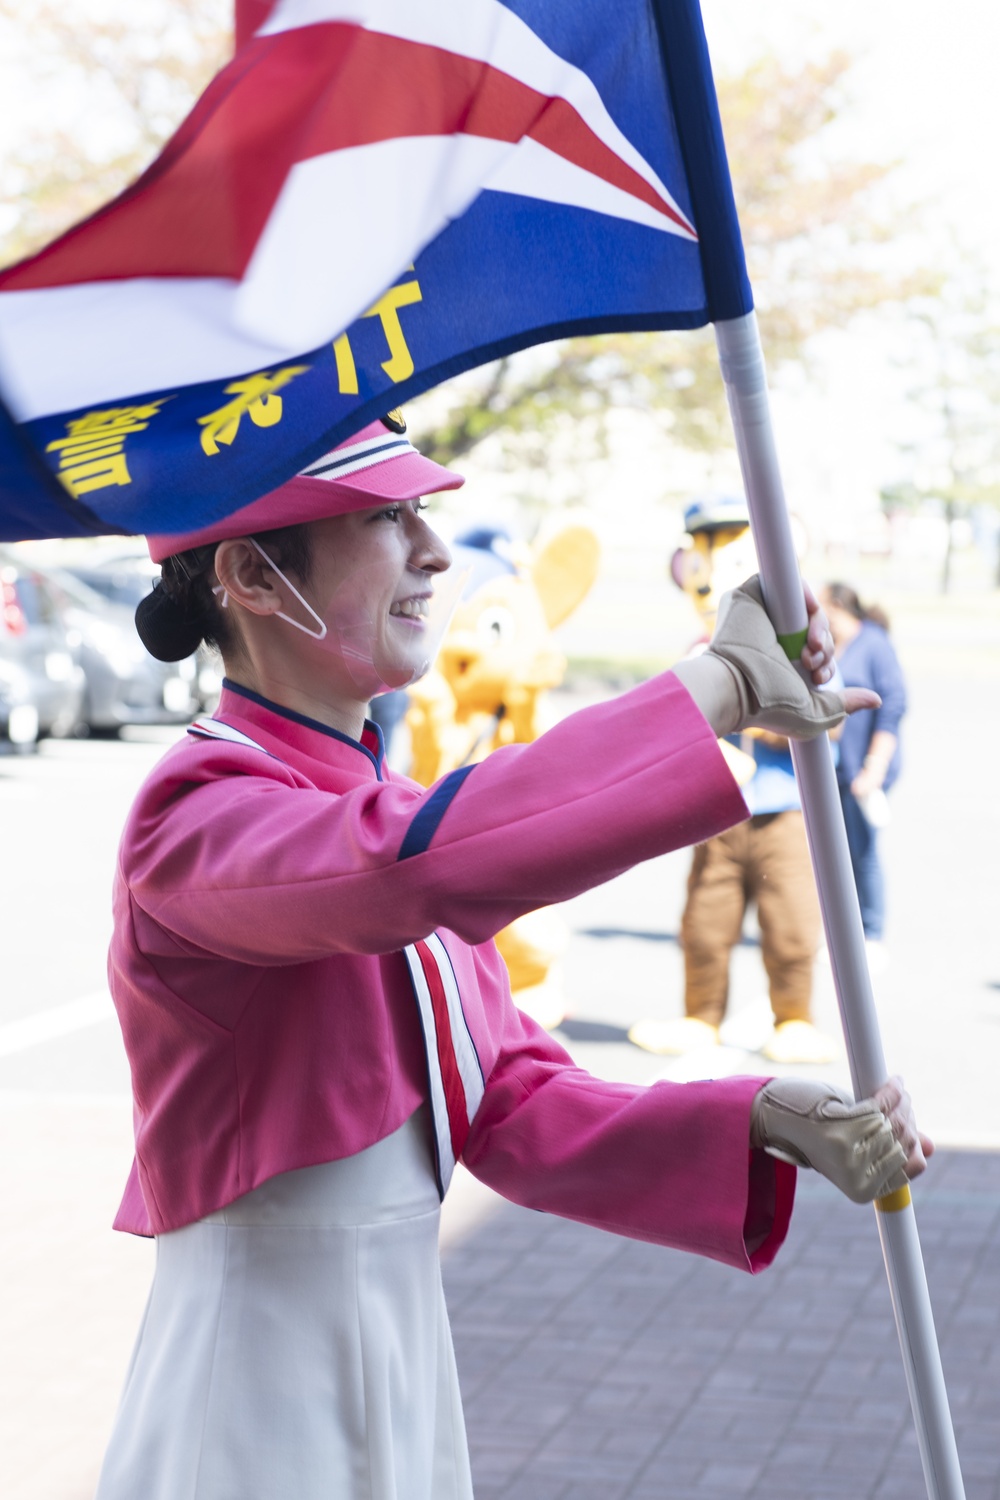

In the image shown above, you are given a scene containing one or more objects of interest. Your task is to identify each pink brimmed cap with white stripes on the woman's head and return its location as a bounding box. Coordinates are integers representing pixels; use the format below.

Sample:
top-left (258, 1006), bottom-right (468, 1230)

top-left (145, 413), bottom-right (465, 563)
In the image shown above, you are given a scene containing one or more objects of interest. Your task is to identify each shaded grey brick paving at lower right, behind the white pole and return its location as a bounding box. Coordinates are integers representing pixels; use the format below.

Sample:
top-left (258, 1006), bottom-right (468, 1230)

top-left (445, 1152), bottom-right (1000, 1500)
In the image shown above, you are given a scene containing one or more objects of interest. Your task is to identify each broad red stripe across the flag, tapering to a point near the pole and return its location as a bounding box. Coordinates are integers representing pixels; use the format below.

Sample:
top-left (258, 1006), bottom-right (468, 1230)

top-left (0, 21), bottom-right (693, 291)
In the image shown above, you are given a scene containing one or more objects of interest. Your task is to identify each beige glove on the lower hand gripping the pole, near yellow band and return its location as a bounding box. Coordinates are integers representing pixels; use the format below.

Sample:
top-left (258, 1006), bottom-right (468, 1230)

top-left (750, 1079), bottom-right (907, 1203)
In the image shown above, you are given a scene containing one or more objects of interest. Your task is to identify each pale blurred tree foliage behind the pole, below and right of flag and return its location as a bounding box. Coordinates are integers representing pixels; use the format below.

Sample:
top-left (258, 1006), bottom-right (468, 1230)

top-left (407, 53), bottom-right (931, 465)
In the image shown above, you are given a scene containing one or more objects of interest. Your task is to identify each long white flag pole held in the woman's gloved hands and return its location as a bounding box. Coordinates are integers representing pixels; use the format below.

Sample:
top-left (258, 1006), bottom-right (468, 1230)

top-left (715, 312), bottom-right (966, 1500)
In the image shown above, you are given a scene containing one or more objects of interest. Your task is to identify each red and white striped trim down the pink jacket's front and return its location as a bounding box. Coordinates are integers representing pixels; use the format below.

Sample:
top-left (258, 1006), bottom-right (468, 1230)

top-left (403, 933), bottom-right (486, 1199)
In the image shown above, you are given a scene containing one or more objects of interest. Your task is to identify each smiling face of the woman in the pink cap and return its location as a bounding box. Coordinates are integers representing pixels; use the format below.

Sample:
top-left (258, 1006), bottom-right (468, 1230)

top-left (282, 501), bottom-right (451, 702)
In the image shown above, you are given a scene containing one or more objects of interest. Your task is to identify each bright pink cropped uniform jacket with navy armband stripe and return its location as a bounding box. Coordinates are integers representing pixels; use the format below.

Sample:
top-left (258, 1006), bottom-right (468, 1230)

top-left (109, 674), bottom-right (795, 1271)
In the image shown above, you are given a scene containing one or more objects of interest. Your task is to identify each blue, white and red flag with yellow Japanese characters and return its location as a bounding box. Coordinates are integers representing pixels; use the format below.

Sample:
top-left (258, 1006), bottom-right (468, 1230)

top-left (0, 0), bottom-right (753, 540)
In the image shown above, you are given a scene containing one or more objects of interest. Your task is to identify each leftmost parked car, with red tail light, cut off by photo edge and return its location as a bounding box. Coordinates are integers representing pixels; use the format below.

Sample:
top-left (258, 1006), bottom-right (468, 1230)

top-left (0, 551), bottom-right (85, 752)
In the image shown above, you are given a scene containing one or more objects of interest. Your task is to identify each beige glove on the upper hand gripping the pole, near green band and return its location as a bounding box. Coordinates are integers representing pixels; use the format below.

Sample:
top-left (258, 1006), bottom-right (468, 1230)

top-left (708, 576), bottom-right (846, 740)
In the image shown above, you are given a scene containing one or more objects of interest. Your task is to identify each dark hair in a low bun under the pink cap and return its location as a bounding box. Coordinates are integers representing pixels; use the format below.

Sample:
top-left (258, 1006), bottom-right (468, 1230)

top-left (135, 522), bottom-right (312, 662)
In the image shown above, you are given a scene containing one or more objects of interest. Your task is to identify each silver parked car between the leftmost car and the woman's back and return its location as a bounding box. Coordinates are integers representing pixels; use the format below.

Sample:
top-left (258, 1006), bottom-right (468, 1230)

top-left (46, 569), bottom-right (201, 734)
